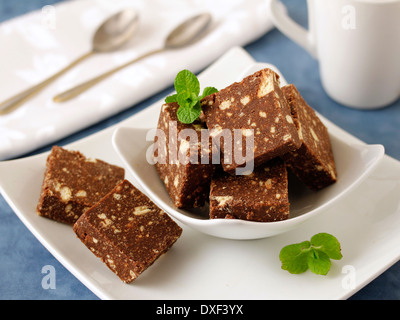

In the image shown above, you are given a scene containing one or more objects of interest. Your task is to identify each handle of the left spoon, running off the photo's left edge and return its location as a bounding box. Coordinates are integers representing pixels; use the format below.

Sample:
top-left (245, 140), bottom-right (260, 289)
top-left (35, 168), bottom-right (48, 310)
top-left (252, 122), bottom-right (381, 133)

top-left (0, 51), bottom-right (93, 115)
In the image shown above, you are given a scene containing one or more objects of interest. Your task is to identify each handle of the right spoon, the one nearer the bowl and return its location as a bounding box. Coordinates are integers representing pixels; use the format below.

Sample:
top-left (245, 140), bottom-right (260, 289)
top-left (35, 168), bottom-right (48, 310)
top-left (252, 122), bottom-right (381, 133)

top-left (53, 48), bottom-right (165, 102)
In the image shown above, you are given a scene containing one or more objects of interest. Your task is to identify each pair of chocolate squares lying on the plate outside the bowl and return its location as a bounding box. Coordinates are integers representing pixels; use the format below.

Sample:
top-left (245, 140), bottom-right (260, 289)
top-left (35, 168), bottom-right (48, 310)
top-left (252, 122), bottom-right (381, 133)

top-left (37, 146), bottom-right (182, 283)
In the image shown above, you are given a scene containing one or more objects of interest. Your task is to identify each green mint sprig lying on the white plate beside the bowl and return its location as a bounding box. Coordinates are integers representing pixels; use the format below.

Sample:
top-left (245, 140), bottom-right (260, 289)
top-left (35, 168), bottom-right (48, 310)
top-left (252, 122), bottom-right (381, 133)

top-left (279, 233), bottom-right (342, 275)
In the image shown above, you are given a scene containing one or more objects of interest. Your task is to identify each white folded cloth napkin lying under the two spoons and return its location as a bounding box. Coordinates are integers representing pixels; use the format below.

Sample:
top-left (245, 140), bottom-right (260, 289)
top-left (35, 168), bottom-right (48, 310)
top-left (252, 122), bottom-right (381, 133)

top-left (0, 0), bottom-right (272, 160)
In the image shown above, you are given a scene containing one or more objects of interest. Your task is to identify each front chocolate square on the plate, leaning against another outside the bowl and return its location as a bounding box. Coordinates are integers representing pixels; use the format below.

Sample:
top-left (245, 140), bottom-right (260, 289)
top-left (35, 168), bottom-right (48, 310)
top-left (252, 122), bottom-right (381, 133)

top-left (73, 180), bottom-right (182, 283)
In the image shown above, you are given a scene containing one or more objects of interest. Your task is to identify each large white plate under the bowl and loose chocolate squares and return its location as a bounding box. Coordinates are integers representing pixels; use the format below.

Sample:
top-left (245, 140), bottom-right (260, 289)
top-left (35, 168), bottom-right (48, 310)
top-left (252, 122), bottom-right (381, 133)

top-left (0, 48), bottom-right (400, 300)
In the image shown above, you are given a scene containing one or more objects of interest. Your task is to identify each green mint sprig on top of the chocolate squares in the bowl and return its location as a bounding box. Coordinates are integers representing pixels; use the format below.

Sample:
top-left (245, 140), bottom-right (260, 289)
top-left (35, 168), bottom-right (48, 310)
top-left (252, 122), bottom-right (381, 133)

top-left (165, 70), bottom-right (218, 124)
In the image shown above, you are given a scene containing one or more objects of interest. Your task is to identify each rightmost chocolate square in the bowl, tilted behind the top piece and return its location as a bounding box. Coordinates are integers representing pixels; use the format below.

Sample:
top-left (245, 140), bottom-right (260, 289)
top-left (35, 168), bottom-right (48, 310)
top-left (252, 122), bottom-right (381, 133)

top-left (282, 84), bottom-right (337, 190)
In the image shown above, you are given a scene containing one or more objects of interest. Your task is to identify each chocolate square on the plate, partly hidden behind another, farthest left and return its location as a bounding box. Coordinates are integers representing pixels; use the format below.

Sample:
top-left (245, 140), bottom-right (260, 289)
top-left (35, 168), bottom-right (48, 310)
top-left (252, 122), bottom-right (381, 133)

top-left (37, 146), bottom-right (125, 225)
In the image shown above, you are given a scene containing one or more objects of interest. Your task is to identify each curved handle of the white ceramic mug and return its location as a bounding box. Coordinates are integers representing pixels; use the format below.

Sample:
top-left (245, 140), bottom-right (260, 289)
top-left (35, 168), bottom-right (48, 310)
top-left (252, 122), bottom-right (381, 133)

top-left (268, 0), bottom-right (317, 58)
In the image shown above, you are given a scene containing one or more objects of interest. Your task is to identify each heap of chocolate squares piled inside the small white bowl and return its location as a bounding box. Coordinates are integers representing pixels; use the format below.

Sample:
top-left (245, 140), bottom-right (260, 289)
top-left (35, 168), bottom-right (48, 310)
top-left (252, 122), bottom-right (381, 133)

top-left (155, 69), bottom-right (337, 222)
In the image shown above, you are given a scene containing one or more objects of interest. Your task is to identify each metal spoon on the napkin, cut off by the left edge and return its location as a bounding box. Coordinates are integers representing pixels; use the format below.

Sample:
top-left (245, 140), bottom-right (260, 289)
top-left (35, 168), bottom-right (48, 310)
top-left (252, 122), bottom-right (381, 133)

top-left (0, 9), bottom-right (139, 115)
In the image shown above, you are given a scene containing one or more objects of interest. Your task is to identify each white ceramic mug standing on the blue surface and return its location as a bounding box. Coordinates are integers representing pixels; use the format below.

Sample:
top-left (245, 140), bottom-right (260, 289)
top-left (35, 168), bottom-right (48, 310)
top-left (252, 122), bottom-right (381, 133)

top-left (269, 0), bottom-right (400, 109)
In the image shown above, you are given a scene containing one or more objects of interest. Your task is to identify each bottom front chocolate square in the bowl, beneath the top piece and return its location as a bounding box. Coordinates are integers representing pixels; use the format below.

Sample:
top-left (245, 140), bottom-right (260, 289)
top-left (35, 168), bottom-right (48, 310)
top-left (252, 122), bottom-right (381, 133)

top-left (210, 158), bottom-right (290, 222)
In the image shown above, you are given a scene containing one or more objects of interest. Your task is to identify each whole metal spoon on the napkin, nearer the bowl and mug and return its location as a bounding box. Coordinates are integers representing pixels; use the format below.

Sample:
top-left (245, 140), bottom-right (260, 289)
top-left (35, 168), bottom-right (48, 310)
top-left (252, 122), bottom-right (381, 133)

top-left (53, 13), bottom-right (212, 102)
